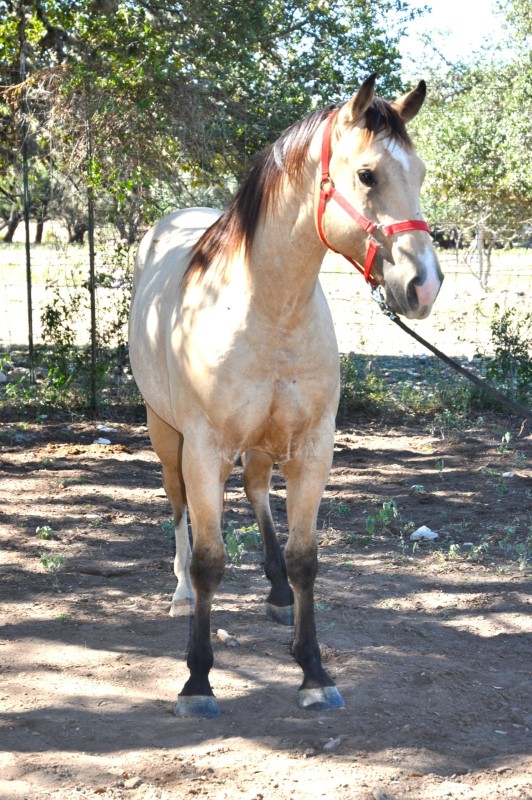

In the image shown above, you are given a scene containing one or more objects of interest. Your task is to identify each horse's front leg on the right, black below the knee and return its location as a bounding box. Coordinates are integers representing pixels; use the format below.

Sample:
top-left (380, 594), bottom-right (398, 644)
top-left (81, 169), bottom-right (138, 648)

top-left (283, 424), bottom-right (344, 710)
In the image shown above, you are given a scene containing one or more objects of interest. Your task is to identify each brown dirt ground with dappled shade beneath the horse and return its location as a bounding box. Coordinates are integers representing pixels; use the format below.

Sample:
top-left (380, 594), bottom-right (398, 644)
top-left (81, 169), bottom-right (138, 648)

top-left (0, 417), bottom-right (532, 800)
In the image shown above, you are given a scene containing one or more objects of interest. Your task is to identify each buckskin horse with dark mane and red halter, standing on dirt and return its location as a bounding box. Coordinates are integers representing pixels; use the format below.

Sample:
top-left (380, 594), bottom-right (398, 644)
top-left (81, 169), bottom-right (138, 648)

top-left (129, 75), bottom-right (443, 718)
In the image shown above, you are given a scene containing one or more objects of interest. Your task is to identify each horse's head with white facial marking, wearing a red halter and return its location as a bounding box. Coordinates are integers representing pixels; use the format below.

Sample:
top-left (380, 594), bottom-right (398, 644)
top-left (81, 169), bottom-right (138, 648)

top-left (318, 75), bottom-right (443, 319)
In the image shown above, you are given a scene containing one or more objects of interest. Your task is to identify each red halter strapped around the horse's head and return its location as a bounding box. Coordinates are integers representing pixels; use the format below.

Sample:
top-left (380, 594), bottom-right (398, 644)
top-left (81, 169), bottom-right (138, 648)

top-left (317, 111), bottom-right (430, 286)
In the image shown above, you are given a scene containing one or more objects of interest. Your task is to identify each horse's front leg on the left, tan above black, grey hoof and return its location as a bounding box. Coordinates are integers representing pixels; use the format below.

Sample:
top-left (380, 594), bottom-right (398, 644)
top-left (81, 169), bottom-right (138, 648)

top-left (174, 437), bottom-right (232, 718)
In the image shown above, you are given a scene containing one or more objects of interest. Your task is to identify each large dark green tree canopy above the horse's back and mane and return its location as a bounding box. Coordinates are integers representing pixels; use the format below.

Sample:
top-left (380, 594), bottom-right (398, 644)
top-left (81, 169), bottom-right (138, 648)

top-left (0, 0), bottom-right (422, 238)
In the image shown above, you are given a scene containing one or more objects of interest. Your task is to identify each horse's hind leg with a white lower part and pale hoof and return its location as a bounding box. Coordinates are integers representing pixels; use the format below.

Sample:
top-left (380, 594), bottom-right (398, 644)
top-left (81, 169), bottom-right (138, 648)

top-left (147, 406), bottom-right (194, 617)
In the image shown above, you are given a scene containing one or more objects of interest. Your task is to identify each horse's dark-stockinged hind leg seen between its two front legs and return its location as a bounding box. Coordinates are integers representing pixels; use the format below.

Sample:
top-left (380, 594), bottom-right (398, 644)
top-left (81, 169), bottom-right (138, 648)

top-left (242, 450), bottom-right (294, 625)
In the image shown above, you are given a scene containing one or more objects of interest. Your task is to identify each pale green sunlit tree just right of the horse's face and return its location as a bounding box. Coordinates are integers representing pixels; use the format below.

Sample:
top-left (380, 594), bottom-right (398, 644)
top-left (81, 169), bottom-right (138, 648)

top-left (413, 47), bottom-right (532, 287)
